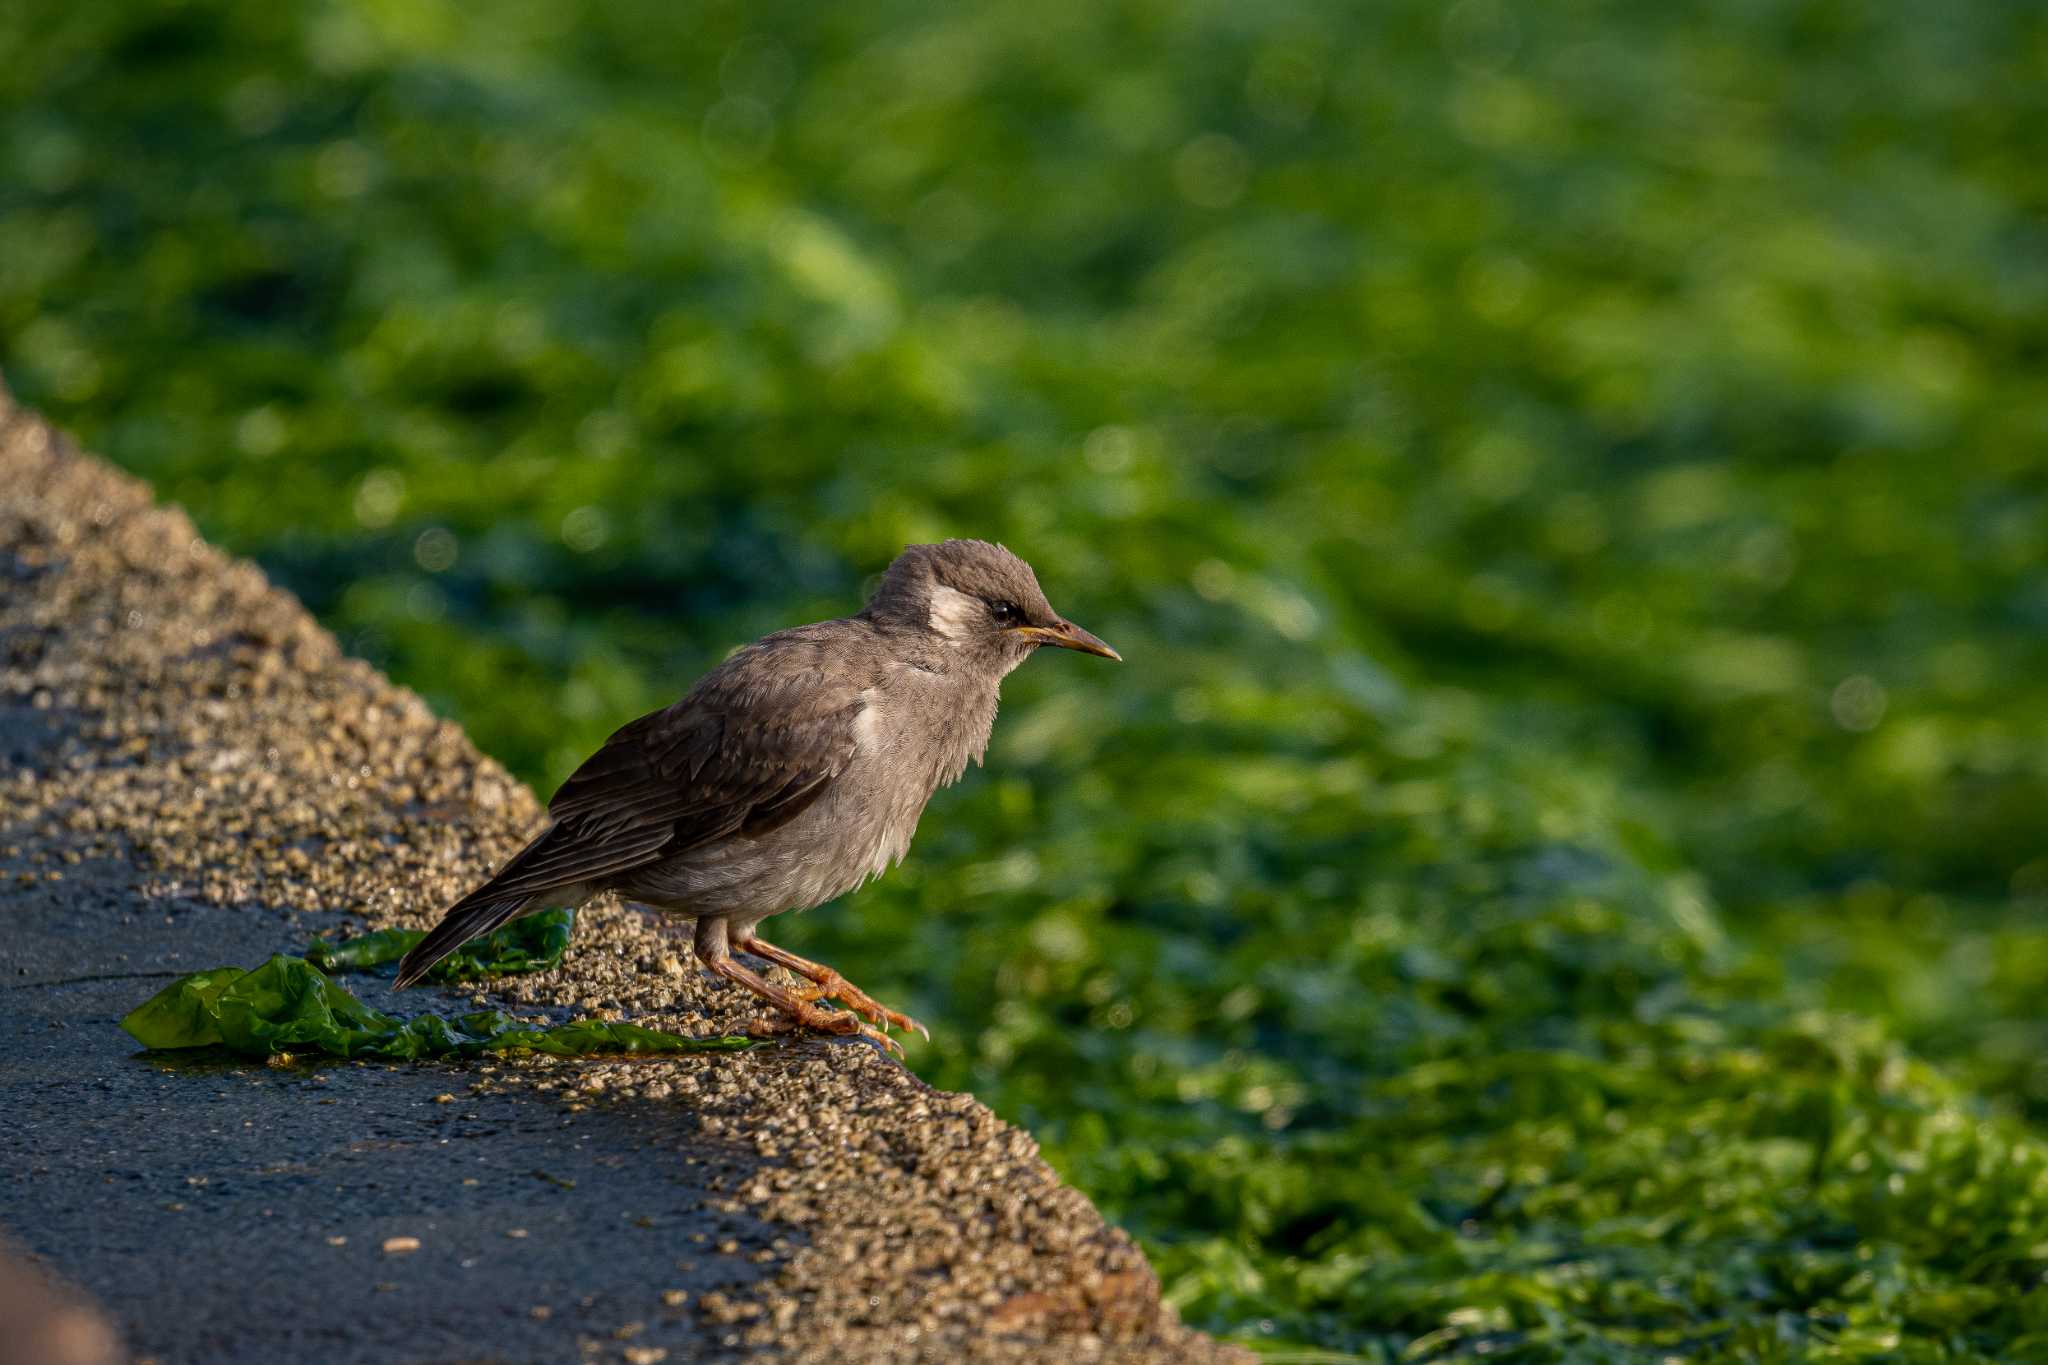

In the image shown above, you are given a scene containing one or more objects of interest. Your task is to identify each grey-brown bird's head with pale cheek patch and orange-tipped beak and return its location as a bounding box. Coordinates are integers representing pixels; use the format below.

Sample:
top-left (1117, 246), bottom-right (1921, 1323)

top-left (868, 540), bottom-right (1120, 675)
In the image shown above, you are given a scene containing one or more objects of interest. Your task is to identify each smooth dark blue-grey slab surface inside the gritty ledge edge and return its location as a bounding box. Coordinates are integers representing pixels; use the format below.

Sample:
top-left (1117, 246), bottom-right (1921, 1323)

top-left (0, 862), bottom-right (788, 1365)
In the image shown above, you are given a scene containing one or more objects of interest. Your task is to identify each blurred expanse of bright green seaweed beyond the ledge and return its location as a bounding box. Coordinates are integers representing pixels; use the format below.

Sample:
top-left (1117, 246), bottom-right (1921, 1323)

top-left (0, 0), bottom-right (2048, 1361)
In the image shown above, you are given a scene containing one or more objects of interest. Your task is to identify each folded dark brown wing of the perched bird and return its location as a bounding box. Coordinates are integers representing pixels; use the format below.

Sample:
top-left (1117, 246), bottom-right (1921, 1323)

top-left (473, 628), bottom-right (868, 898)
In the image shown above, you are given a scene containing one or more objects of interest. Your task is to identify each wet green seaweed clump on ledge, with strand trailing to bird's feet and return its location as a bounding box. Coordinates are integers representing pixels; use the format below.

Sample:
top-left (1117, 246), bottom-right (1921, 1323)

top-left (121, 954), bottom-right (752, 1062)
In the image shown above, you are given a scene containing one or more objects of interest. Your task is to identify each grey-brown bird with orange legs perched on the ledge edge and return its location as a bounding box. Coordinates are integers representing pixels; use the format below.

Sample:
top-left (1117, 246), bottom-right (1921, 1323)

top-left (397, 540), bottom-right (1120, 1056)
